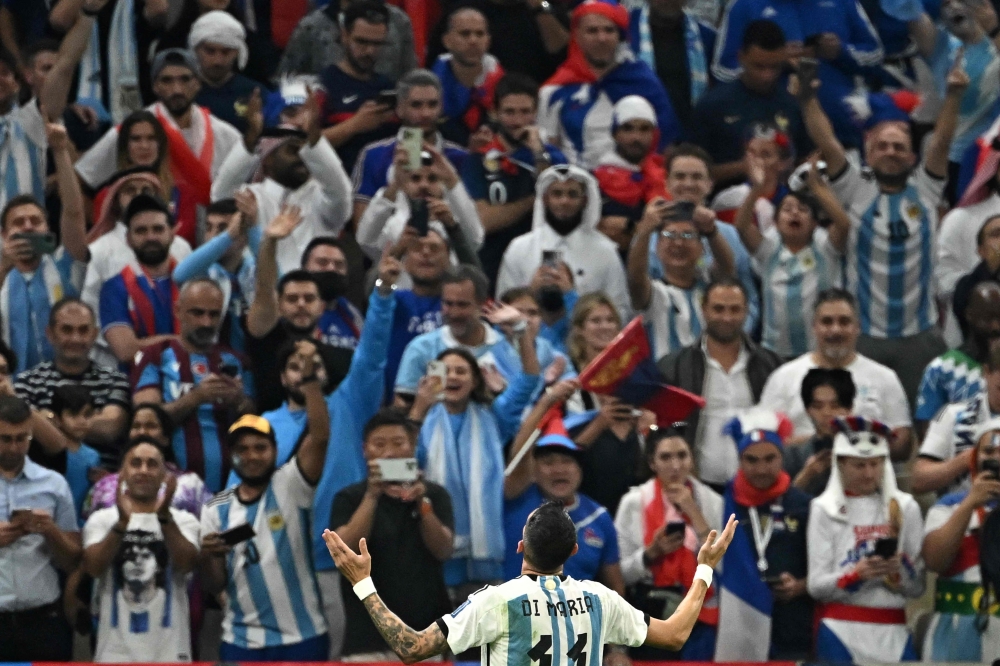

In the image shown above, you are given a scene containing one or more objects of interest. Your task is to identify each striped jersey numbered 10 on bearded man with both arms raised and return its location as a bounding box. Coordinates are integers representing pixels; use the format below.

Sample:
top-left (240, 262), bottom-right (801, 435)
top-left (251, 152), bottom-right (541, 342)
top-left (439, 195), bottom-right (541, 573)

top-left (830, 164), bottom-right (945, 338)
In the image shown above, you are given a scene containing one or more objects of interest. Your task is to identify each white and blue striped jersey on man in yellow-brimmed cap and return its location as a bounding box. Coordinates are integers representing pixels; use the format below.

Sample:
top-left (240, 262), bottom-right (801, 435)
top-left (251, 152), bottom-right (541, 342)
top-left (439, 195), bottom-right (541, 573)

top-left (201, 457), bottom-right (327, 650)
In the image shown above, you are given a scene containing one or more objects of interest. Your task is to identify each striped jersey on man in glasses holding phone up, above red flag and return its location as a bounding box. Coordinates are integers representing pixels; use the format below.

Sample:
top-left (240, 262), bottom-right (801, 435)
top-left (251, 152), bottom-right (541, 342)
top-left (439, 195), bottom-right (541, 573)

top-left (643, 280), bottom-right (706, 360)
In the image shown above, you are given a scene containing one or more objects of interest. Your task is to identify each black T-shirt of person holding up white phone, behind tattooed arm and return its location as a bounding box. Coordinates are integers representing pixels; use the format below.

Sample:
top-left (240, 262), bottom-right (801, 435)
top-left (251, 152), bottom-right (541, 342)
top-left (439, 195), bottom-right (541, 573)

top-left (329, 481), bottom-right (454, 656)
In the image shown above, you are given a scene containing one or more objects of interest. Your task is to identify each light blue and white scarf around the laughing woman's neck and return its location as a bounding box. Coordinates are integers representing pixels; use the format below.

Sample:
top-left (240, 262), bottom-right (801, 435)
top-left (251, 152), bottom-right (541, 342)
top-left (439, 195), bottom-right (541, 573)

top-left (419, 402), bottom-right (504, 580)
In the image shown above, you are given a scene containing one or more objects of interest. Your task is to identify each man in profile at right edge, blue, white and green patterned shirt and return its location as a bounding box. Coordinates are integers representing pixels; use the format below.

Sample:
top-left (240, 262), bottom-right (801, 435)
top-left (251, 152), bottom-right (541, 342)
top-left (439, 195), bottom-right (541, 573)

top-left (914, 280), bottom-right (1000, 434)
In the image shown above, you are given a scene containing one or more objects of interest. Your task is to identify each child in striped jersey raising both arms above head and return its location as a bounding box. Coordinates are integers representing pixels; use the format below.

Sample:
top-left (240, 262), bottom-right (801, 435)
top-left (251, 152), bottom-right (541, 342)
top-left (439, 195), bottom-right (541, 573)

top-left (736, 155), bottom-right (851, 358)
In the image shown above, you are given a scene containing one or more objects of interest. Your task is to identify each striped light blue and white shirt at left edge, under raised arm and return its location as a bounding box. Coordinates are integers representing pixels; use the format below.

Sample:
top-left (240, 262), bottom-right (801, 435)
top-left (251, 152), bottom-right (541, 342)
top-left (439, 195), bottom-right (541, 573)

top-left (0, 98), bottom-right (49, 208)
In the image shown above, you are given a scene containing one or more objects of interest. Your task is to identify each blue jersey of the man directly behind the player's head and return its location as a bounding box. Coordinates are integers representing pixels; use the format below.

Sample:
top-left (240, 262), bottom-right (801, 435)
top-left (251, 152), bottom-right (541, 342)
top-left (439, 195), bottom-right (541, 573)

top-left (503, 484), bottom-right (619, 580)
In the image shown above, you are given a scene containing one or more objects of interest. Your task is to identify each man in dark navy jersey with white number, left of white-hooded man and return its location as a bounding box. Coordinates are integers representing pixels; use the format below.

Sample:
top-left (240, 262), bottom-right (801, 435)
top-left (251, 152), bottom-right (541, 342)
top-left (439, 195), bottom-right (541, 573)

top-left (462, 73), bottom-right (566, 283)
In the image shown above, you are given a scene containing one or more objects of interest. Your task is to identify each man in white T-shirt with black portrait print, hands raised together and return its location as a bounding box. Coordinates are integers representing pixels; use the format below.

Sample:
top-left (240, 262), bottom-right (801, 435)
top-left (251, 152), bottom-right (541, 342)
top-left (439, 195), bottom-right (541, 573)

top-left (83, 437), bottom-right (199, 662)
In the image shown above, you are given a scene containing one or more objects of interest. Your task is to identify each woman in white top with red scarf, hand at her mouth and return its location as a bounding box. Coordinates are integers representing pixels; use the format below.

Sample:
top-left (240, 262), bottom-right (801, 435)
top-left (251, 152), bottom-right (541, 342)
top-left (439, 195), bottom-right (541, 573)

top-left (615, 427), bottom-right (723, 661)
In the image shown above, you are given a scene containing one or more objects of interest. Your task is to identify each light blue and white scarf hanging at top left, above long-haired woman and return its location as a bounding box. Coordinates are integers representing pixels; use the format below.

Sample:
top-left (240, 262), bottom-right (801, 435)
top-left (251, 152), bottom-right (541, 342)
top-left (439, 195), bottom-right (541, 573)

top-left (77, 0), bottom-right (142, 124)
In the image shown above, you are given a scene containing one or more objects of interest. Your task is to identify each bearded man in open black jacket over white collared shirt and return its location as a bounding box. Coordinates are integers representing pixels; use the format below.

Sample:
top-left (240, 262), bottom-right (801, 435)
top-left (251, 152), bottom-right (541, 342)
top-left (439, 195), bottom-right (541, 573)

top-left (657, 278), bottom-right (781, 492)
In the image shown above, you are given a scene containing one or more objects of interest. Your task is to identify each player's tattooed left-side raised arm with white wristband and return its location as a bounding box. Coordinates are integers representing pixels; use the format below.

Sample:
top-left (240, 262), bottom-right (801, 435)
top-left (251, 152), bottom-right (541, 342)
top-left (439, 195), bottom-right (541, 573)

top-left (323, 530), bottom-right (448, 664)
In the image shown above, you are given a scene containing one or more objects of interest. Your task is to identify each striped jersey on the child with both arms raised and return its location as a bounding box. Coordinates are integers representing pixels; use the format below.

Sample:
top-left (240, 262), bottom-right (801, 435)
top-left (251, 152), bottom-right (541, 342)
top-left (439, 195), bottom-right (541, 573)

top-left (753, 227), bottom-right (840, 358)
